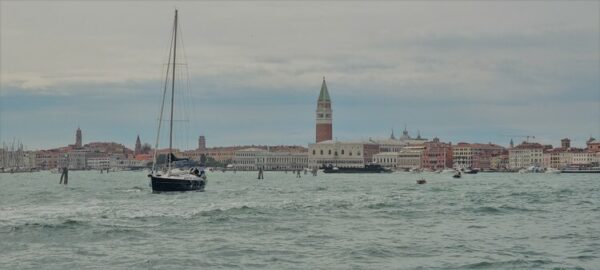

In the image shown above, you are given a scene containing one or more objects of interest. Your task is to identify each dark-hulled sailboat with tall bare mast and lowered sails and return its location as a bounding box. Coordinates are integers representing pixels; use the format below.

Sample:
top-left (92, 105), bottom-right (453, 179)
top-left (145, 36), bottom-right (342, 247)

top-left (148, 10), bottom-right (207, 192)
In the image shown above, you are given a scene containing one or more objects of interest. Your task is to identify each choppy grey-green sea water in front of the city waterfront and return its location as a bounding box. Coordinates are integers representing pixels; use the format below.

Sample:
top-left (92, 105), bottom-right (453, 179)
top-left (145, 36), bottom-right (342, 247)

top-left (0, 171), bottom-right (600, 269)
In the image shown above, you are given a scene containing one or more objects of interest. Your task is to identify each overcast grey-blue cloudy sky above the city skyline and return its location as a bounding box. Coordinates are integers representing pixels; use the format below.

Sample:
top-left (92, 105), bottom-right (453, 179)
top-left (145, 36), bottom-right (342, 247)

top-left (0, 0), bottom-right (600, 149)
